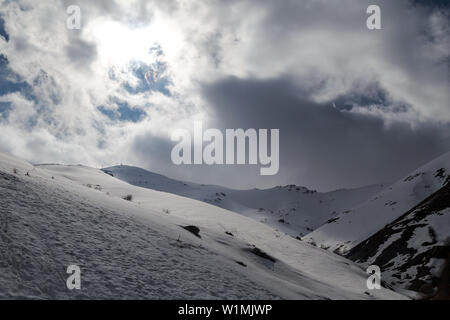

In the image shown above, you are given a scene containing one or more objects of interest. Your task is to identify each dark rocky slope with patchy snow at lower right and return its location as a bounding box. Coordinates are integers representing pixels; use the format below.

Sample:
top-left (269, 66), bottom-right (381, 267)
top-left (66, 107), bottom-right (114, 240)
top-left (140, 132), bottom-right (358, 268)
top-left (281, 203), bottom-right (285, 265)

top-left (346, 183), bottom-right (450, 294)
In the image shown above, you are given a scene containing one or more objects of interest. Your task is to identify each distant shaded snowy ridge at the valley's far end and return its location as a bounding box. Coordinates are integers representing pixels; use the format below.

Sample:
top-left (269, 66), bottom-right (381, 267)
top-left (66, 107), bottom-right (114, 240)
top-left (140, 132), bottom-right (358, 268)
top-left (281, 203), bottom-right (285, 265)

top-left (103, 165), bottom-right (383, 237)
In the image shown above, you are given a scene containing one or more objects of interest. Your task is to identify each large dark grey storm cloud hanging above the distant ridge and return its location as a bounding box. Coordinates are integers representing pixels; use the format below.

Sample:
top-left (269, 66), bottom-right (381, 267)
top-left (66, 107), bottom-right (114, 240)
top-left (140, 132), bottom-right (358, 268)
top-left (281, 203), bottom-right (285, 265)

top-left (204, 78), bottom-right (450, 189)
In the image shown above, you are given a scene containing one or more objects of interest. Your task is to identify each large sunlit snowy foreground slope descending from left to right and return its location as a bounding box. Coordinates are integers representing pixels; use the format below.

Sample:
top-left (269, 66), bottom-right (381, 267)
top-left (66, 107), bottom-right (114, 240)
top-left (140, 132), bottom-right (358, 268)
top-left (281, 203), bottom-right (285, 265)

top-left (0, 154), bottom-right (404, 299)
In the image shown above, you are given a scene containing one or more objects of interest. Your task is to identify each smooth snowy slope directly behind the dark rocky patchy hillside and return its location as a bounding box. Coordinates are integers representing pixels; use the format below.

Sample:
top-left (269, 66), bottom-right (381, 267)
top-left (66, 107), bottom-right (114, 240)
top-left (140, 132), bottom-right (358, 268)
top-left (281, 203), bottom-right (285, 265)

top-left (303, 153), bottom-right (450, 253)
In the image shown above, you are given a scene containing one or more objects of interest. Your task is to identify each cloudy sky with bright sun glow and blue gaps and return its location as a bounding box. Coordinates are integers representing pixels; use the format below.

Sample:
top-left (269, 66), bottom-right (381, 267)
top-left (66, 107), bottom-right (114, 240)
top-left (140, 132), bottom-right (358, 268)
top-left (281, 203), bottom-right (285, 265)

top-left (0, 0), bottom-right (450, 191)
